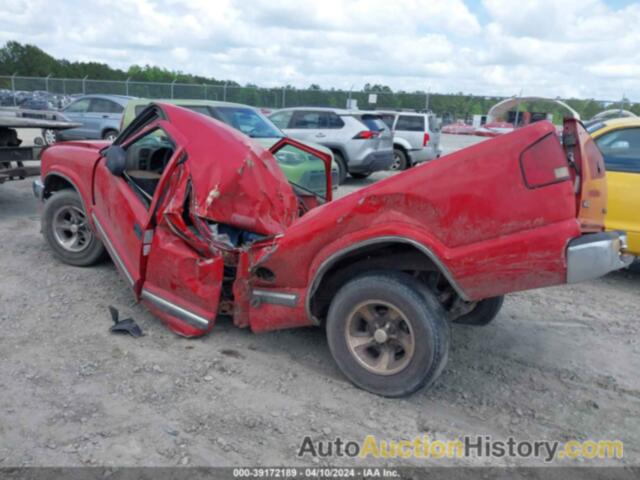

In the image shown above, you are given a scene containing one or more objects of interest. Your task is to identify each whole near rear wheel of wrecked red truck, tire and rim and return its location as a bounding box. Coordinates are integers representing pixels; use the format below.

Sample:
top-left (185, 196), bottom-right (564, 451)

top-left (327, 272), bottom-right (450, 397)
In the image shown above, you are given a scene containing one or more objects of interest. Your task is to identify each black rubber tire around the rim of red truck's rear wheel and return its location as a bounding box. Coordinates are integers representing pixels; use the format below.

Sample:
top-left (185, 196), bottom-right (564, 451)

top-left (326, 272), bottom-right (450, 397)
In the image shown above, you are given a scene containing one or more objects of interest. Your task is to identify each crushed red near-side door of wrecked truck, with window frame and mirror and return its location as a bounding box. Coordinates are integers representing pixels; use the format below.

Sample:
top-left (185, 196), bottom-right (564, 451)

top-left (92, 107), bottom-right (223, 336)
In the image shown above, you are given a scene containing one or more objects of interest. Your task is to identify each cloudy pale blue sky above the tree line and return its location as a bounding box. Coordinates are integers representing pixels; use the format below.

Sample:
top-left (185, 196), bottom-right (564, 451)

top-left (0, 0), bottom-right (640, 101)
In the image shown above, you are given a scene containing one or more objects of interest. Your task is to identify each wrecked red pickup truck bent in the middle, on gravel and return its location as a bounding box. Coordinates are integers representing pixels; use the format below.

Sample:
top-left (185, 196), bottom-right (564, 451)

top-left (34, 104), bottom-right (630, 396)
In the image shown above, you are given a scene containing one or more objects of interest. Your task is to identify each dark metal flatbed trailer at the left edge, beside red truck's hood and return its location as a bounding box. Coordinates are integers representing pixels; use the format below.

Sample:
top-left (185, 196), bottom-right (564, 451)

top-left (0, 108), bottom-right (80, 184)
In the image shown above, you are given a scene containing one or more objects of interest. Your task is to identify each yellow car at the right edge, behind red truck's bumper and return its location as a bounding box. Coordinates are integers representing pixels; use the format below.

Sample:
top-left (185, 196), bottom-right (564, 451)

top-left (587, 117), bottom-right (640, 256)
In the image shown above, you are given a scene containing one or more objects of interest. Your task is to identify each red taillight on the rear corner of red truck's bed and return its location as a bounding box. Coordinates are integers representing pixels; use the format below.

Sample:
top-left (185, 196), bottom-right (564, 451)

top-left (520, 133), bottom-right (571, 188)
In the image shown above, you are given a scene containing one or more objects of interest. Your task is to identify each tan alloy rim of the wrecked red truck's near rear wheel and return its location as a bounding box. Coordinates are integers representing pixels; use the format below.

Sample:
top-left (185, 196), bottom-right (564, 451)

top-left (345, 300), bottom-right (415, 375)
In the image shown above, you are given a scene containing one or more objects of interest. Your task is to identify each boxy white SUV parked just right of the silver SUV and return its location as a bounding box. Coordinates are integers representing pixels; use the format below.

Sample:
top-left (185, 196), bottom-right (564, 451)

top-left (372, 110), bottom-right (442, 170)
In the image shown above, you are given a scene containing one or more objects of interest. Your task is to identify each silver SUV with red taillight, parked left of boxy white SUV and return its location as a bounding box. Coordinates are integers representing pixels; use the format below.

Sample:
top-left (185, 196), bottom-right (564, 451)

top-left (269, 107), bottom-right (393, 183)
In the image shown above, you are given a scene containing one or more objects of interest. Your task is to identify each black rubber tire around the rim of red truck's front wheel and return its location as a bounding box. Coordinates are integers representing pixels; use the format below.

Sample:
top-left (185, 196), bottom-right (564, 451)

top-left (42, 190), bottom-right (105, 267)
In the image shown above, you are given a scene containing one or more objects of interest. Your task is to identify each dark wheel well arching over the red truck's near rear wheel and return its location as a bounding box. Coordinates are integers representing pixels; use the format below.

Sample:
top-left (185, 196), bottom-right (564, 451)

top-left (309, 241), bottom-right (457, 321)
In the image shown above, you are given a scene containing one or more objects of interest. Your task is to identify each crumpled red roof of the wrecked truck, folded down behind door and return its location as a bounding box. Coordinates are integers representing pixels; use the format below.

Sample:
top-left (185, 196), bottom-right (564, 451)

top-left (160, 104), bottom-right (298, 235)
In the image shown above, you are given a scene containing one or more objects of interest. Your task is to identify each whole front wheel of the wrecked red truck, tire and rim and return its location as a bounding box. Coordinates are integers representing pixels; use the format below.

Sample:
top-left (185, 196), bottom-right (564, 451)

top-left (42, 190), bottom-right (105, 267)
